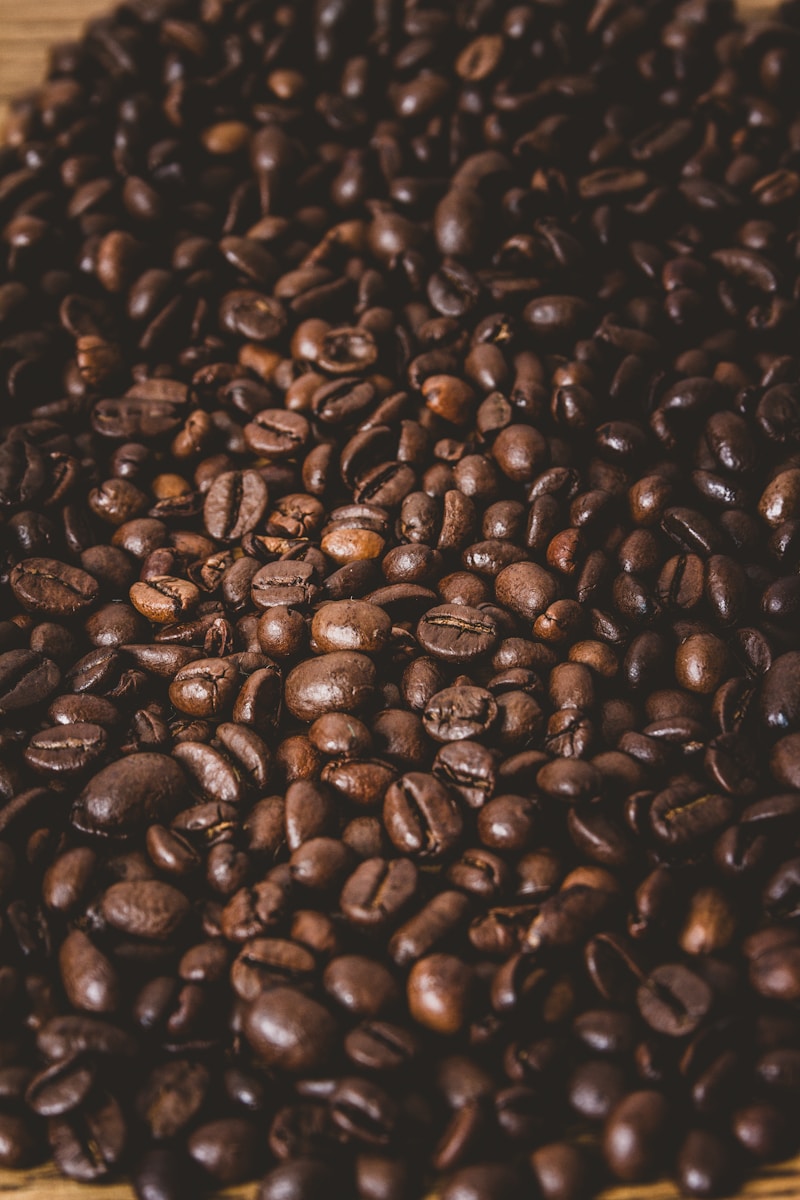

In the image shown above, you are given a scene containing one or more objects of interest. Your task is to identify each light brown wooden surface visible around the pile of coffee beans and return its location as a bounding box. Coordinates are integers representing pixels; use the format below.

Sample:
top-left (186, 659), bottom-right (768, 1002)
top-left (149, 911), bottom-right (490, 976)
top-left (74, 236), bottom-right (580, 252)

top-left (0, 0), bottom-right (800, 1200)
